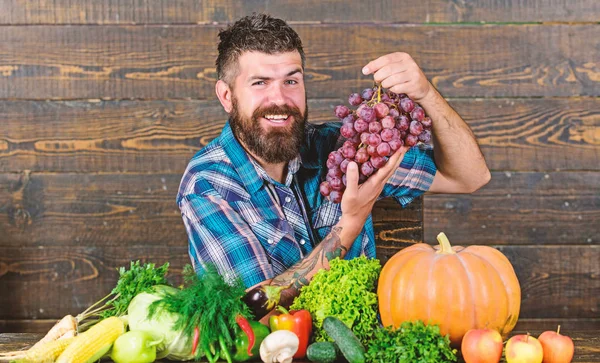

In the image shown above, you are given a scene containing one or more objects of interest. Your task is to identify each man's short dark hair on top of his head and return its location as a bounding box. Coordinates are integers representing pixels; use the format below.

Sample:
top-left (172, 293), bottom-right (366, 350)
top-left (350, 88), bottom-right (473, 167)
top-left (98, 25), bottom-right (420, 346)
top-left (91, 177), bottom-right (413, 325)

top-left (216, 13), bottom-right (305, 86)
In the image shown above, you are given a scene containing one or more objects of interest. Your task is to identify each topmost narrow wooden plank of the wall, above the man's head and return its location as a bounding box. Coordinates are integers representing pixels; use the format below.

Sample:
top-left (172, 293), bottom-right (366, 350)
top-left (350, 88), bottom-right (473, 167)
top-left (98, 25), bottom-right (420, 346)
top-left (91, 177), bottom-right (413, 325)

top-left (0, 0), bottom-right (600, 24)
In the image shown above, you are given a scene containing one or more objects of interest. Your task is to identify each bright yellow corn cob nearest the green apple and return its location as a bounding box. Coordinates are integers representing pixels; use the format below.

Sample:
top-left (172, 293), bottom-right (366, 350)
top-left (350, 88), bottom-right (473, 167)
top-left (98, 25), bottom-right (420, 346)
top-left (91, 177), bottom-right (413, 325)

top-left (56, 316), bottom-right (125, 363)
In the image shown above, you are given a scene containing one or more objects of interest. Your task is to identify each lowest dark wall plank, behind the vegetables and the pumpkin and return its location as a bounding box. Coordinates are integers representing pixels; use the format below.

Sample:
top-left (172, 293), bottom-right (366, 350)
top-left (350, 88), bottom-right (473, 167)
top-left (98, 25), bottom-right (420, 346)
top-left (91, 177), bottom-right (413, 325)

top-left (0, 245), bottom-right (600, 320)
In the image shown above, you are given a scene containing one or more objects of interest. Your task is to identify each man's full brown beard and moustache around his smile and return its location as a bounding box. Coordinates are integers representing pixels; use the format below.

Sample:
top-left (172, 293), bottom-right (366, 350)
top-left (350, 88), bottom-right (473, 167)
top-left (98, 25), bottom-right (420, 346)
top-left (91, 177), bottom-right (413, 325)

top-left (229, 97), bottom-right (308, 164)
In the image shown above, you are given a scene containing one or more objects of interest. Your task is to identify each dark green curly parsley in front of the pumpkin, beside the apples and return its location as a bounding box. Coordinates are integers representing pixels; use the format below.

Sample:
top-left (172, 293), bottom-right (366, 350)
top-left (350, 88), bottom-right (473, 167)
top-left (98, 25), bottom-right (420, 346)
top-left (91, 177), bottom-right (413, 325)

top-left (366, 320), bottom-right (457, 363)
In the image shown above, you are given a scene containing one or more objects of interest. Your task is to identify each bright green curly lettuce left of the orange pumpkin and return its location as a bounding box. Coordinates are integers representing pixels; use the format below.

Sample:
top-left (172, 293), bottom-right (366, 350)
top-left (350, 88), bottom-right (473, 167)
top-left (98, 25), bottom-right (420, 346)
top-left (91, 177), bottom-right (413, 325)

top-left (290, 256), bottom-right (381, 346)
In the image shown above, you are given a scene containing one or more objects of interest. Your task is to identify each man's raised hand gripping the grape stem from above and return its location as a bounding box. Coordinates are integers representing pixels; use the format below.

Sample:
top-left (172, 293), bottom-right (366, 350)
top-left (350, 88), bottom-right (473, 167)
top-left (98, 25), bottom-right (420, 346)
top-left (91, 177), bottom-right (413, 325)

top-left (362, 52), bottom-right (433, 102)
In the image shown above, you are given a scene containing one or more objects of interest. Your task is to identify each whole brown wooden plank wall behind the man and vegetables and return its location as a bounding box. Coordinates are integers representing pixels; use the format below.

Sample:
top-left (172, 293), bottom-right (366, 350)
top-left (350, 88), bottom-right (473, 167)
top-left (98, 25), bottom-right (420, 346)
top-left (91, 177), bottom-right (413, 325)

top-left (0, 0), bottom-right (600, 331)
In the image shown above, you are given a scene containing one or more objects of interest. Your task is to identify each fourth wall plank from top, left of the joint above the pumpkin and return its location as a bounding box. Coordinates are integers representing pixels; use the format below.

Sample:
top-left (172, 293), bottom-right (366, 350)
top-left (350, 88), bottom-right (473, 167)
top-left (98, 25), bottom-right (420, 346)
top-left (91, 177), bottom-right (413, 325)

top-left (0, 172), bottom-right (423, 248)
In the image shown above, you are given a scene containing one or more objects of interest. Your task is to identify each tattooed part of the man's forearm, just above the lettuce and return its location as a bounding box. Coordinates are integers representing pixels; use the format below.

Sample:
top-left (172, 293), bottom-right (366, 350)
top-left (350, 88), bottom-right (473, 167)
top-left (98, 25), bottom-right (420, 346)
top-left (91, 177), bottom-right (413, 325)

top-left (271, 227), bottom-right (348, 295)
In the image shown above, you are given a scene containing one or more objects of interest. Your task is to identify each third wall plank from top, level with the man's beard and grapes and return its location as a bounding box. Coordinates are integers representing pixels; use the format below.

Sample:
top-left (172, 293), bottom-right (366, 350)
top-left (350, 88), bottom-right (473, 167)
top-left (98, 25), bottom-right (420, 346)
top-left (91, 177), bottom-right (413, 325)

top-left (0, 98), bottom-right (600, 173)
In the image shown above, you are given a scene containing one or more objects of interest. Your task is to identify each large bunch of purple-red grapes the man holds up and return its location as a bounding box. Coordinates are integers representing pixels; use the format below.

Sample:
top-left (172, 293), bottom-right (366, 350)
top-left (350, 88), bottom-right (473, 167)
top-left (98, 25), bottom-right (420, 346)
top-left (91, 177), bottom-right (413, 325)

top-left (320, 87), bottom-right (431, 203)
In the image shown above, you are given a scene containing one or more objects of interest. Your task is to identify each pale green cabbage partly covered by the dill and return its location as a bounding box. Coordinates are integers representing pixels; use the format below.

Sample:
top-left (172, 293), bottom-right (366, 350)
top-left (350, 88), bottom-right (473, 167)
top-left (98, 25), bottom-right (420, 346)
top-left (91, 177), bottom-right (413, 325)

top-left (127, 285), bottom-right (194, 361)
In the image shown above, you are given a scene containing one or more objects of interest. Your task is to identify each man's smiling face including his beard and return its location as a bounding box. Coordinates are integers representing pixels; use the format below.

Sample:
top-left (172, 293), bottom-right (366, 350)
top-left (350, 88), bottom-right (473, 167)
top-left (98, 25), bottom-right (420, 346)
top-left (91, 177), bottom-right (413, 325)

top-left (222, 51), bottom-right (308, 164)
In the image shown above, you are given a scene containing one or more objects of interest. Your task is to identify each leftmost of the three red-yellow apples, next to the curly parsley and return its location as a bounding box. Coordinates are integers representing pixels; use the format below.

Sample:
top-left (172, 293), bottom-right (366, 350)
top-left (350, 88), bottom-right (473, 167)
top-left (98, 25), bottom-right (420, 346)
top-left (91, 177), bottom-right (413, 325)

top-left (460, 329), bottom-right (503, 363)
